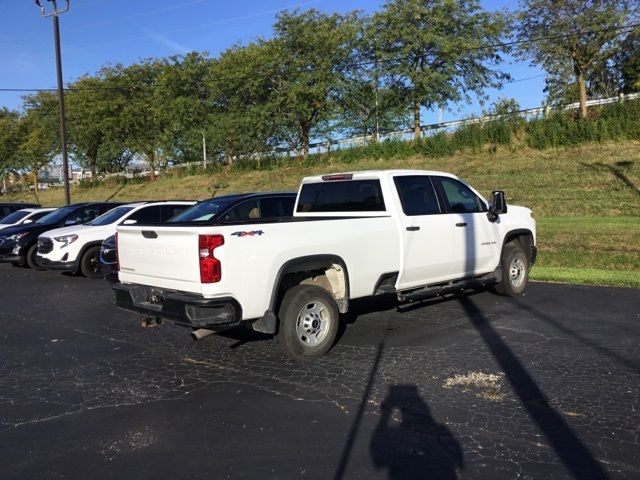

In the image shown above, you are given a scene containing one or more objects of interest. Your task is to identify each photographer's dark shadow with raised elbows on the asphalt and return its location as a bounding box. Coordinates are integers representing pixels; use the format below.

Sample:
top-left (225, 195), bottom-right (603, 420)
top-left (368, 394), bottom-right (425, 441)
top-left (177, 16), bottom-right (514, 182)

top-left (369, 385), bottom-right (464, 480)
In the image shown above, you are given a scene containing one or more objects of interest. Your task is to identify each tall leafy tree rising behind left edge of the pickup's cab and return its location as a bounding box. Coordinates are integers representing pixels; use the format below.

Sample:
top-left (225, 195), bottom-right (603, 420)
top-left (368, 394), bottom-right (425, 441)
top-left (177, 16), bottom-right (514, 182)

top-left (262, 9), bottom-right (359, 158)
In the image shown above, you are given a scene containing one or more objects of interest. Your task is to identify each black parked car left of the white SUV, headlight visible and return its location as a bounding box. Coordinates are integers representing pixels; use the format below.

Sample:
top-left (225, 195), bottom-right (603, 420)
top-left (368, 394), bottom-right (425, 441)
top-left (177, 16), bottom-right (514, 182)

top-left (0, 202), bottom-right (122, 269)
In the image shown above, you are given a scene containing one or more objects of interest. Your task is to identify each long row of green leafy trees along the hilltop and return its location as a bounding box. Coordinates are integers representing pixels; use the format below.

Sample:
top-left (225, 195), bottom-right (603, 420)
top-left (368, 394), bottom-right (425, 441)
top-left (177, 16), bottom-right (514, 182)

top-left (0, 0), bottom-right (640, 184)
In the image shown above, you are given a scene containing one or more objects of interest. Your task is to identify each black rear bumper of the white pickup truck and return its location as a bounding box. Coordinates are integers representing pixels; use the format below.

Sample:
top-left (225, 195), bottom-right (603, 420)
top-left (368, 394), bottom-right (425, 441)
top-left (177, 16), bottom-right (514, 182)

top-left (111, 283), bottom-right (242, 330)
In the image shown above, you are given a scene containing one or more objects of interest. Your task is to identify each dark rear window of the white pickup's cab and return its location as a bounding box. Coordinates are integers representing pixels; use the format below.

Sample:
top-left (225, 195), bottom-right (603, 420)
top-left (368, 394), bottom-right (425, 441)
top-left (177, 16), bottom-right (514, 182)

top-left (296, 180), bottom-right (385, 213)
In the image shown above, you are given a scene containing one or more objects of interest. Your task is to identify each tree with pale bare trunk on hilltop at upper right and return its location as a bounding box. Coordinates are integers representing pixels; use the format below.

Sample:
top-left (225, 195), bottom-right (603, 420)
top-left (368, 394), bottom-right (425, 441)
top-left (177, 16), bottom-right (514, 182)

top-left (517, 0), bottom-right (637, 118)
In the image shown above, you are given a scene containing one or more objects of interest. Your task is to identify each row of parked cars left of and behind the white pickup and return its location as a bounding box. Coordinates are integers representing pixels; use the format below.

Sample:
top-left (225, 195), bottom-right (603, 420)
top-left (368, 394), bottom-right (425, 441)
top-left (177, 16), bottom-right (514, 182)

top-left (0, 192), bottom-right (296, 282)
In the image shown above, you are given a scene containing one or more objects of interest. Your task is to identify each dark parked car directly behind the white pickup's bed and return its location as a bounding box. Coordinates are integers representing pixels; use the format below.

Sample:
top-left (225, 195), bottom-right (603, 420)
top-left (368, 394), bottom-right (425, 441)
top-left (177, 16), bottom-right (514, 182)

top-left (100, 192), bottom-right (296, 282)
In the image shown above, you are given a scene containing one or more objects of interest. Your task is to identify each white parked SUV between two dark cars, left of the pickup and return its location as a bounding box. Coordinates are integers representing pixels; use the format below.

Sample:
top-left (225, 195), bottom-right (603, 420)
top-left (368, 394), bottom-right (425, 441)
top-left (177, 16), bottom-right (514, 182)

top-left (36, 201), bottom-right (196, 278)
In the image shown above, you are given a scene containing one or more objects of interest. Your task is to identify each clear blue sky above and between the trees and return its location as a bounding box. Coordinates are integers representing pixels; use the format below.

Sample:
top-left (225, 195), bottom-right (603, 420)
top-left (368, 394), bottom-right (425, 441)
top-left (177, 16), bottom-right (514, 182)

top-left (0, 0), bottom-right (544, 123)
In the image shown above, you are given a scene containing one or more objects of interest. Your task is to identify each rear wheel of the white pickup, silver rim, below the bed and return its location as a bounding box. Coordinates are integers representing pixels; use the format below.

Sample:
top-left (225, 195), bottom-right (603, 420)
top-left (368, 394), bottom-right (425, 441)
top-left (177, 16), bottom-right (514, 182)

top-left (277, 285), bottom-right (340, 360)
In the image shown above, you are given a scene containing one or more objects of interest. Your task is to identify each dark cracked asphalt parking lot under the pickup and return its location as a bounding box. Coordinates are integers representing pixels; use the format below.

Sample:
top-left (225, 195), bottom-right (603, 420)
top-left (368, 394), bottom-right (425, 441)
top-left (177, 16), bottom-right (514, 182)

top-left (0, 265), bottom-right (640, 479)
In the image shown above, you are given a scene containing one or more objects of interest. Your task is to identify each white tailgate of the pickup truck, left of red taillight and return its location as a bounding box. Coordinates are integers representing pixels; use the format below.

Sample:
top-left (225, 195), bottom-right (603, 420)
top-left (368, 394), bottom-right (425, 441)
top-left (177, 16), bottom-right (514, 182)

top-left (118, 226), bottom-right (200, 291)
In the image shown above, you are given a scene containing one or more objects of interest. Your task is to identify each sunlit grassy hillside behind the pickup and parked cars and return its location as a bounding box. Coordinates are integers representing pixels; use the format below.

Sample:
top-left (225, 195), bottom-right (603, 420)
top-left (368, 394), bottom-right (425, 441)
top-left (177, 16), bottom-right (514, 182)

top-left (4, 141), bottom-right (640, 287)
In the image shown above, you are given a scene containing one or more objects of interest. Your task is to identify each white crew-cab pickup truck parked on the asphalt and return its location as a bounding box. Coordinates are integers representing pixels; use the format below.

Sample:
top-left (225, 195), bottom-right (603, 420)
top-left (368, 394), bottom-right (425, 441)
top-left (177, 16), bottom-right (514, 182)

top-left (113, 170), bottom-right (536, 359)
